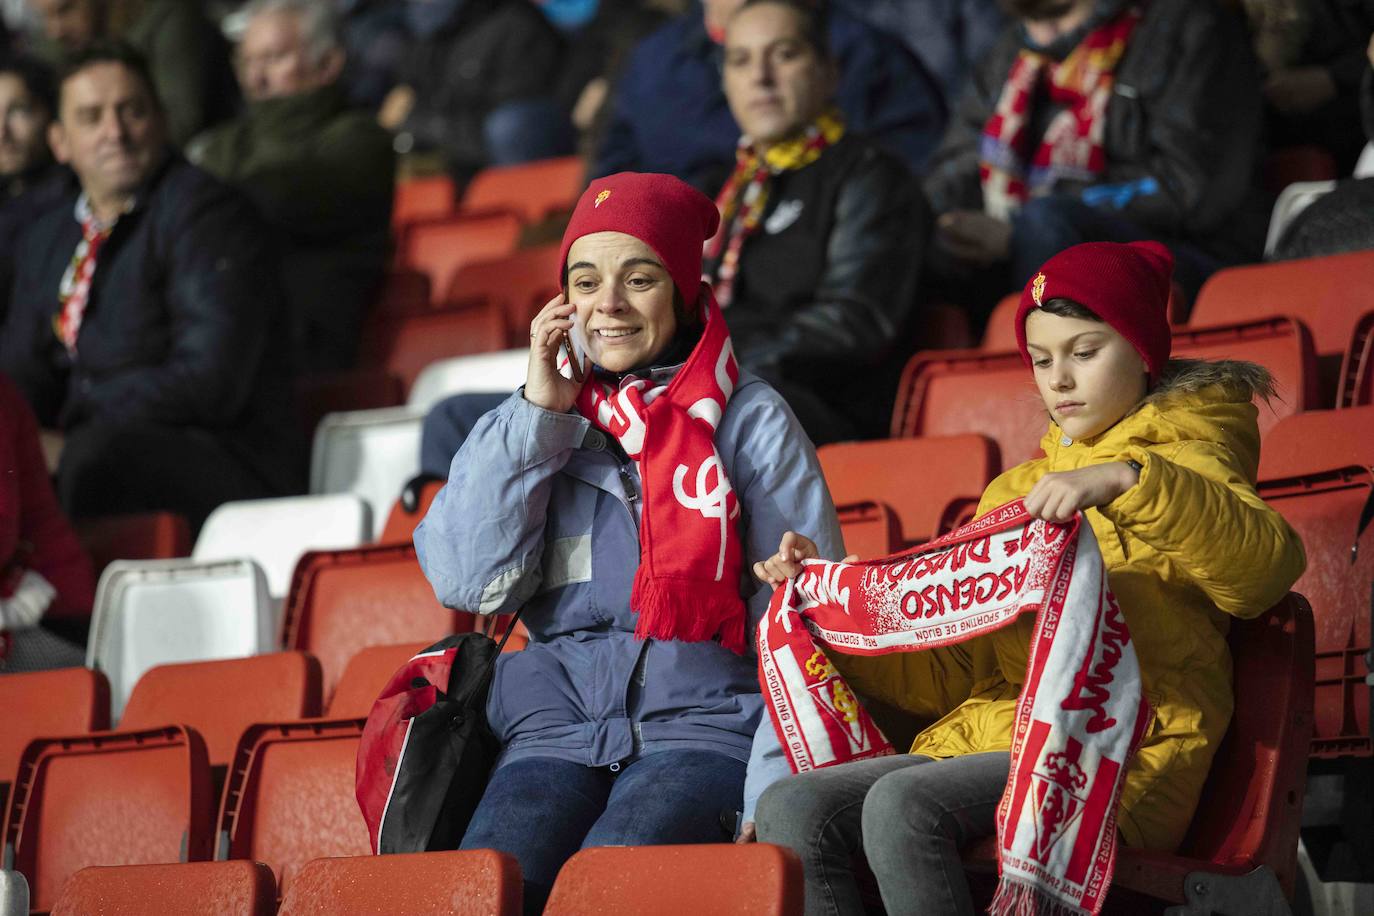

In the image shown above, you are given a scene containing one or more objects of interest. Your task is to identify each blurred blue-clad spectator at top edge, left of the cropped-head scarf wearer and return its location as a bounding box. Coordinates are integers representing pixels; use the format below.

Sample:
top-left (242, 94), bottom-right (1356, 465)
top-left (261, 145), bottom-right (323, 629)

top-left (841, 0), bottom-right (1006, 107)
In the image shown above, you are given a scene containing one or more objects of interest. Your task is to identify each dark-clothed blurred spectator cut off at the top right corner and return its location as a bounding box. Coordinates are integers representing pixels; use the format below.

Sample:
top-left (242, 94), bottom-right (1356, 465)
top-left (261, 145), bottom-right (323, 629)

top-left (1242, 0), bottom-right (1374, 174)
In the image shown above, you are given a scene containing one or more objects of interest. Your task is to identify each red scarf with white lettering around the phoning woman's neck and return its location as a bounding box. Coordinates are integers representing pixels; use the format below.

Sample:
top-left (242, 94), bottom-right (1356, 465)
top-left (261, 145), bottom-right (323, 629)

top-left (577, 284), bottom-right (746, 654)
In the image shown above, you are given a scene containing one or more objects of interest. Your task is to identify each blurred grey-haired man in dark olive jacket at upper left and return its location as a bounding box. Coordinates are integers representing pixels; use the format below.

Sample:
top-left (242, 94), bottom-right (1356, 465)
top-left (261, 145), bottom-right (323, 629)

top-left (187, 0), bottom-right (396, 371)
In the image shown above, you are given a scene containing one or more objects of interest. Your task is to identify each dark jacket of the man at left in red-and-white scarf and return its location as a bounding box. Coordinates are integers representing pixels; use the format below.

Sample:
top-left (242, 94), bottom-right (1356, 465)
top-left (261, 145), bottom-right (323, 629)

top-left (0, 158), bottom-right (304, 493)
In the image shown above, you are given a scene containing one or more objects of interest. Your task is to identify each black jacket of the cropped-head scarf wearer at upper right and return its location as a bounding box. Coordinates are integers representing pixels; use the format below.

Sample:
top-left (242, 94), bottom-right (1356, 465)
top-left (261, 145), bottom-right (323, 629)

top-left (925, 0), bottom-right (1270, 260)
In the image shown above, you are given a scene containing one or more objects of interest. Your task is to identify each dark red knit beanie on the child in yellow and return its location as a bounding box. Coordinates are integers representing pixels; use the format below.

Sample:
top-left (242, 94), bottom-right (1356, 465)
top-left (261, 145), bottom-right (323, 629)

top-left (1017, 242), bottom-right (1173, 385)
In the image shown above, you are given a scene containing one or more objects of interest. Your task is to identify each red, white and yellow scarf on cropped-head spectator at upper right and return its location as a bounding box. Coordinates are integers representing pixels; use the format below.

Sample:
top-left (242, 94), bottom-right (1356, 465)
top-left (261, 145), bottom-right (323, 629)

top-left (978, 7), bottom-right (1142, 220)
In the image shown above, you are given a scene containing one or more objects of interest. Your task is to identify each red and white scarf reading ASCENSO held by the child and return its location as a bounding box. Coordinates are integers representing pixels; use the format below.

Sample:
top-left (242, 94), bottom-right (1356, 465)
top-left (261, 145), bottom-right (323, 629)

top-left (758, 500), bottom-right (1150, 913)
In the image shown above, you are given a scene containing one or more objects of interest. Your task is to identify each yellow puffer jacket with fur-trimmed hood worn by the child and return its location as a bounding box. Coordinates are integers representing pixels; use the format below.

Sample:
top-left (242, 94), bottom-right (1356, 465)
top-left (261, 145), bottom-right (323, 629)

top-left (835, 360), bottom-right (1307, 850)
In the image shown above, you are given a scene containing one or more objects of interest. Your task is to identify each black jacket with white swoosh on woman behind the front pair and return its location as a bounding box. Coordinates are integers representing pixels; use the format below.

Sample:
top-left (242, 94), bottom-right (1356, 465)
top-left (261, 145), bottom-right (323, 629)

top-left (706, 133), bottom-right (930, 433)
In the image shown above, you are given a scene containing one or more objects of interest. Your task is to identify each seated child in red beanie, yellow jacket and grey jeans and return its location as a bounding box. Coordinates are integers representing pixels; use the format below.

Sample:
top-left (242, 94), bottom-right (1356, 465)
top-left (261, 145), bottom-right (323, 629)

top-left (757, 242), bottom-right (1305, 916)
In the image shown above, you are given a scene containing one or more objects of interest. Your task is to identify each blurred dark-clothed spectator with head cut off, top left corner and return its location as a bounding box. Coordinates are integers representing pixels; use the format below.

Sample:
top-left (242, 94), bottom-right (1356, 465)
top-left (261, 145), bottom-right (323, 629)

top-left (29, 0), bottom-right (238, 146)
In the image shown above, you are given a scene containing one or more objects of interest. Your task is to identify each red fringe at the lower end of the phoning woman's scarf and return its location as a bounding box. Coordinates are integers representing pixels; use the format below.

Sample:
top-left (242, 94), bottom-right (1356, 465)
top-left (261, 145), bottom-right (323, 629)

top-left (631, 563), bottom-right (747, 655)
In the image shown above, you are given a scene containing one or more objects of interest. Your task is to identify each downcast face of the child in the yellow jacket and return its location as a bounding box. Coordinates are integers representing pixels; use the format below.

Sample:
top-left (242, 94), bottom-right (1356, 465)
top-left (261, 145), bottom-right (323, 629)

top-left (1026, 309), bottom-right (1147, 439)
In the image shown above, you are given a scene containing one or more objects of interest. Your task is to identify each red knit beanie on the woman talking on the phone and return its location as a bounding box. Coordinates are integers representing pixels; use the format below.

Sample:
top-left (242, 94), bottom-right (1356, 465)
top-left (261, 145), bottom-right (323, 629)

top-left (558, 172), bottom-right (720, 306)
